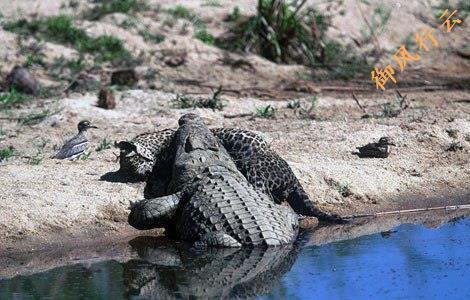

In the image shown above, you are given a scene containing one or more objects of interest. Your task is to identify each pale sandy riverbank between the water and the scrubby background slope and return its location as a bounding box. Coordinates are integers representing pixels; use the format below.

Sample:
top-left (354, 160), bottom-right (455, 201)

top-left (0, 90), bottom-right (470, 253)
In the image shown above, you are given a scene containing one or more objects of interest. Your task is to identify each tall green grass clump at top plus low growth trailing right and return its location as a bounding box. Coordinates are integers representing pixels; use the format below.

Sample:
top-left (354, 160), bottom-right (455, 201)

top-left (215, 0), bottom-right (370, 80)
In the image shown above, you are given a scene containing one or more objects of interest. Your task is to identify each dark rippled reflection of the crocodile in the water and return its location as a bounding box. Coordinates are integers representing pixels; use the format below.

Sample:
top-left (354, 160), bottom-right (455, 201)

top-left (123, 238), bottom-right (299, 299)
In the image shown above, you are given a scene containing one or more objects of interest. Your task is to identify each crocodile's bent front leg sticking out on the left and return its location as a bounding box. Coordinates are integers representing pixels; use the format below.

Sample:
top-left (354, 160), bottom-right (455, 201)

top-left (128, 193), bottom-right (180, 230)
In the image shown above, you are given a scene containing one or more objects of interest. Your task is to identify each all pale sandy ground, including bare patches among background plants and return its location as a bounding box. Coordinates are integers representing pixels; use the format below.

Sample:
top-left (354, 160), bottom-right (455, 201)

top-left (0, 1), bottom-right (470, 250)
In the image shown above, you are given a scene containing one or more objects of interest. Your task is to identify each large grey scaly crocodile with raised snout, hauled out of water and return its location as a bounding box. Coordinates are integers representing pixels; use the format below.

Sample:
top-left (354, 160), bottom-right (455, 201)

top-left (128, 114), bottom-right (298, 247)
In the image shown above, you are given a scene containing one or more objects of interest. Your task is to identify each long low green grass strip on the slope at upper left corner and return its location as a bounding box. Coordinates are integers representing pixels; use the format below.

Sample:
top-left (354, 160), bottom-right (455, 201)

top-left (4, 15), bottom-right (133, 63)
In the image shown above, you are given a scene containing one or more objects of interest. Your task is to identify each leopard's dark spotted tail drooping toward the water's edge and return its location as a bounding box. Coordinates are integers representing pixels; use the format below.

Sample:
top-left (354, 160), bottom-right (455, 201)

top-left (287, 184), bottom-right (346, 223)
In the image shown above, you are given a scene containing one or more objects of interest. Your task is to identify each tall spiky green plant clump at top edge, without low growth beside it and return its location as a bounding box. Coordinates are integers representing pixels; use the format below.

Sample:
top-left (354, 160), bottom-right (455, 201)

top-left (219, 0), bottom-right (329, 64)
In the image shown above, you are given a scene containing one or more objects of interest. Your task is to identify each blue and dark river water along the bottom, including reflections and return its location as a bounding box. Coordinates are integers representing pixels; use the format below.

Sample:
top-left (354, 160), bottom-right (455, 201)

top-left (0, 218), bottom-right (470, 299)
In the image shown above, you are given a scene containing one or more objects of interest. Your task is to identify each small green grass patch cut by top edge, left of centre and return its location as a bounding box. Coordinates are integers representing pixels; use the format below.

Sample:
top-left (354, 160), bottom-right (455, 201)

top-left (85, 0), bottom-right (149, 21)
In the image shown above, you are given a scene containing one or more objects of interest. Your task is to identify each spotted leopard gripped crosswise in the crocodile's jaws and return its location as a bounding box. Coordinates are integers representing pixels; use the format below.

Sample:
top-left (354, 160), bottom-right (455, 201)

top-left (118, 128), bottom-right (343, 222)
